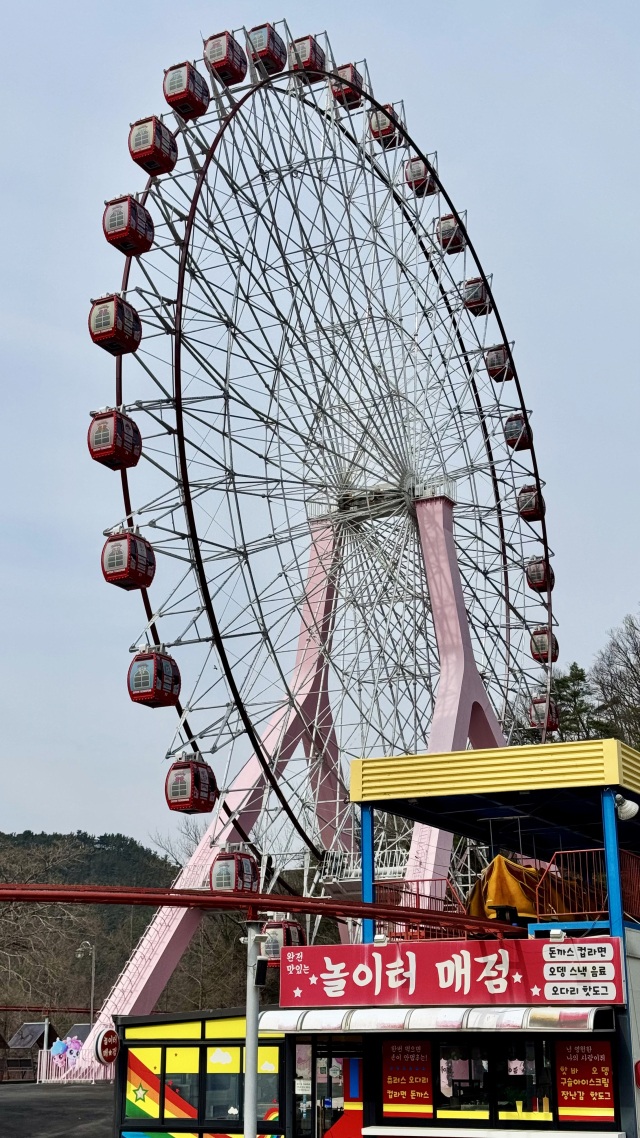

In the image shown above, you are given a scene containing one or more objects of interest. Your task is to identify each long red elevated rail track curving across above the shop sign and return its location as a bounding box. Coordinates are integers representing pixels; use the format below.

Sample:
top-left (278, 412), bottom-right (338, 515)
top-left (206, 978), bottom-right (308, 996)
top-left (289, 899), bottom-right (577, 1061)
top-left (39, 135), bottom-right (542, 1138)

top-left (0, 884), bottom-right (526, 938)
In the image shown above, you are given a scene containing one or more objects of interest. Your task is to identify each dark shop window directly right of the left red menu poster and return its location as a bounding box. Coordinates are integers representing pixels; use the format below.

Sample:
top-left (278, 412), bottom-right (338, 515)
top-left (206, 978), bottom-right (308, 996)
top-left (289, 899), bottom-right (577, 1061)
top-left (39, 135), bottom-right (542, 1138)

top-left (436, 1044), bottom-right (490, 1122)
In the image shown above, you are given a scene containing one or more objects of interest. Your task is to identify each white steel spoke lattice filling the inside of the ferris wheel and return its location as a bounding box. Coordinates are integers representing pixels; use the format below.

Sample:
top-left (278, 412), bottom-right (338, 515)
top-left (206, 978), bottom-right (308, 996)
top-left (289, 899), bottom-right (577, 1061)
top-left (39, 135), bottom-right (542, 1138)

top-left (101, 24), bottom-right (547, 878)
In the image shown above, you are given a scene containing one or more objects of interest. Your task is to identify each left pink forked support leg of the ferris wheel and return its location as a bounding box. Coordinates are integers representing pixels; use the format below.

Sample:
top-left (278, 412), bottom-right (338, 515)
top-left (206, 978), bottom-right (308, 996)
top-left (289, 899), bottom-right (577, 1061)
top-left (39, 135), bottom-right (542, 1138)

top-left (83, 526), bottom-right (352, 1056)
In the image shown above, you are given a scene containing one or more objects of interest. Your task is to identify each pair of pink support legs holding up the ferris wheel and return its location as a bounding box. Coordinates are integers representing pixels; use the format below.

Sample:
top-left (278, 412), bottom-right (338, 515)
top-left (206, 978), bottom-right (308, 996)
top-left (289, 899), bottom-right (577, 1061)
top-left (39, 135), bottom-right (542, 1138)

top-left (85, 494), bottom-right (504, 1053)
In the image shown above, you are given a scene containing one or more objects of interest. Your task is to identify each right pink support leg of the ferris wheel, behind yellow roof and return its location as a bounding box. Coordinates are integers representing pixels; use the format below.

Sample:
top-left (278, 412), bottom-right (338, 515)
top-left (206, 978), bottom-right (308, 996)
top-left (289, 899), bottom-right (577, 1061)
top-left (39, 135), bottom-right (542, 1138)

top-left (405, 497), bottom-right (504, 880)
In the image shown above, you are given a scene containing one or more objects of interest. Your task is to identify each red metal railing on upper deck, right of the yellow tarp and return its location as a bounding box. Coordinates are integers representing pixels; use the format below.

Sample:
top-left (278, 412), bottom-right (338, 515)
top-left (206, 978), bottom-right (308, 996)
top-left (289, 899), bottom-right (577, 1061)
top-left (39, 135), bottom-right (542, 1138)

top-left (535, 849), bottom-right (640, 921)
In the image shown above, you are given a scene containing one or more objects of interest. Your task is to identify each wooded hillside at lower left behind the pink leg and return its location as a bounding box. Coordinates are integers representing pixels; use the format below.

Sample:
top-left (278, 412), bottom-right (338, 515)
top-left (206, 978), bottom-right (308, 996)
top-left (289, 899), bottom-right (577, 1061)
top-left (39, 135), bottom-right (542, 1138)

top-left (0, 831), bottom-right (278, 1038)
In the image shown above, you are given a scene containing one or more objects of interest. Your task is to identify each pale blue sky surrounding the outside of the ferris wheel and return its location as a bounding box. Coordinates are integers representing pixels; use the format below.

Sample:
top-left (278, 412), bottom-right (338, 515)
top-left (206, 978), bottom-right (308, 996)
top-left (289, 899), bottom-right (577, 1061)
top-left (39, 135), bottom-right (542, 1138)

top-left (0, 0), bottom-right (640, 841)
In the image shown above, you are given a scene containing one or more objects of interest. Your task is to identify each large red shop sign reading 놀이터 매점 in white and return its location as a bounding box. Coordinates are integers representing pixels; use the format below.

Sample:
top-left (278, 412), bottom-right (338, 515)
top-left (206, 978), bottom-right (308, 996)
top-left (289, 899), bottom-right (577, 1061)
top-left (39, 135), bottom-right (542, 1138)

top-left (280, 937), bottom-right (625, 1007)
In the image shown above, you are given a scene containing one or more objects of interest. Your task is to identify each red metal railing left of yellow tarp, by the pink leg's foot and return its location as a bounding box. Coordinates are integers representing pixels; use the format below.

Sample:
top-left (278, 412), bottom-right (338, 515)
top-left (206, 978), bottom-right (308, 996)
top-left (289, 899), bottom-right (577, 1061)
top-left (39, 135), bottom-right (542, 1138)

top-left (376, 877), bottom-right (467, 940)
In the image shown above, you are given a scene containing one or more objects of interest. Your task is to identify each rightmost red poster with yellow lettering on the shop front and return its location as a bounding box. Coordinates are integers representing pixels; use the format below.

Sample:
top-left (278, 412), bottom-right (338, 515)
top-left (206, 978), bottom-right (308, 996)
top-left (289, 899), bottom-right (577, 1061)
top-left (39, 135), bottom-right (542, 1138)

top-left (556, 1039), bottom-right (615, 1122)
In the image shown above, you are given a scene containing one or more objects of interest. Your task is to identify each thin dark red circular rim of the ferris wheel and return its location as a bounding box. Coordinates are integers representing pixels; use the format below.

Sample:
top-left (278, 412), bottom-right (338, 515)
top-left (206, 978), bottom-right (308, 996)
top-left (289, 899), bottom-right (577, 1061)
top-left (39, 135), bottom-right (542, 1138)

top-left (116, 62), bottom-right (552, 857)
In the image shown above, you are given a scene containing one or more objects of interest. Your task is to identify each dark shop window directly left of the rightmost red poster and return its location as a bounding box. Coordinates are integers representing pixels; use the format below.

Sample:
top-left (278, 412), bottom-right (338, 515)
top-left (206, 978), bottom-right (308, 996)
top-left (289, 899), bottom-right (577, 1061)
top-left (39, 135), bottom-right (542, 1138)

top-left (495, 1039), bottom-right (553, 1122)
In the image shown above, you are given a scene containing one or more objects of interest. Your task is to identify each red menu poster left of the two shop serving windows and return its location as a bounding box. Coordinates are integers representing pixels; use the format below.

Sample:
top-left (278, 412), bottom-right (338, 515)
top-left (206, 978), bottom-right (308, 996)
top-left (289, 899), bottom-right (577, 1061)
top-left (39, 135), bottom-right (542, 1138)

top-left (383, 1039), bottom-right (434, 1119)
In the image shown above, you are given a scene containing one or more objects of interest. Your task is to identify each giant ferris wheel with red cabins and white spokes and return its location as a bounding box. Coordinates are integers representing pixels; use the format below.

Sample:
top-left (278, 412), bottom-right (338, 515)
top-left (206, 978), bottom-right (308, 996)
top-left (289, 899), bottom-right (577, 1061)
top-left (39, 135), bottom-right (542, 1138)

top-left (89, 22), bottom-right (557, 946)
